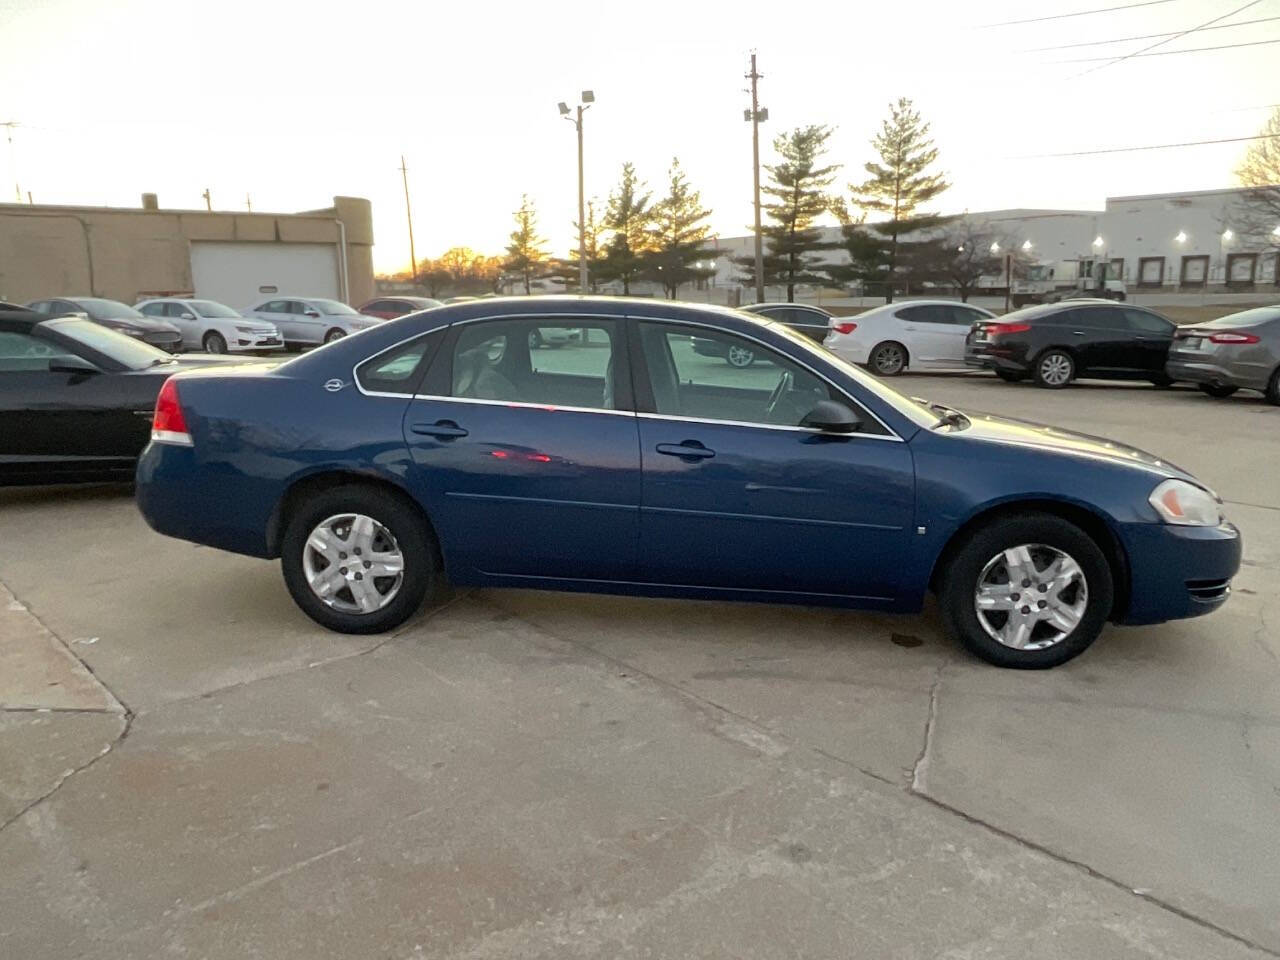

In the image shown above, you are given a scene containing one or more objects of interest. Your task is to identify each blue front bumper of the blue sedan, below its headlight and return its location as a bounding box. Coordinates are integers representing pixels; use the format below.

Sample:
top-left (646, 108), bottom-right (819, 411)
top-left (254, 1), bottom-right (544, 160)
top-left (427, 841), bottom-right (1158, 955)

top-left (1116, 524), bottom-right (1243, 625)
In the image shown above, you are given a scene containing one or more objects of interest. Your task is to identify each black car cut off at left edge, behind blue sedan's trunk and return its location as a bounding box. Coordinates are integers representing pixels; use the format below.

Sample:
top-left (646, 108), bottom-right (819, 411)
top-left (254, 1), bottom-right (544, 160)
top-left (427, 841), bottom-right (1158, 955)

top-left (0, 308), bottom-right (237, 486)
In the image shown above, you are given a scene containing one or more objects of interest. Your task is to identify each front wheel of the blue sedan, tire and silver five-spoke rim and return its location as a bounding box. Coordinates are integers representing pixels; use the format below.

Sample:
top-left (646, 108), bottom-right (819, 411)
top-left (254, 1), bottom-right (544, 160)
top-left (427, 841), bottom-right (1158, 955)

top-left (938, 513), bottom-right (1115, 669)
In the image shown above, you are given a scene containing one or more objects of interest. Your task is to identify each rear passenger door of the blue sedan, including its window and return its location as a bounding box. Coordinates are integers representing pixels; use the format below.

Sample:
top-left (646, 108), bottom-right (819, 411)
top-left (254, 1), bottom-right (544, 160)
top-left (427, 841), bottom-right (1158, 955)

top-left (404, 316), bottom-right (640, 585)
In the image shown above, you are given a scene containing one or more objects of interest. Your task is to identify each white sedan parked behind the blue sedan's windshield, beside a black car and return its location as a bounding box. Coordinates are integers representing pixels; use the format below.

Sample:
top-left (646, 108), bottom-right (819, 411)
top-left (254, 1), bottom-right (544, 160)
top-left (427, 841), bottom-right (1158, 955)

top-left (823, 300), bottom-right (995, 376)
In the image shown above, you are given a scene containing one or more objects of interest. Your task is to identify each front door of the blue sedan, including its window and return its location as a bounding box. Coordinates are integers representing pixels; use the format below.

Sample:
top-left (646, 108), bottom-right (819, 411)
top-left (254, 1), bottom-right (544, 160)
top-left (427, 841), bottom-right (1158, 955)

top-left (636, 321), bottom-right (914, 600)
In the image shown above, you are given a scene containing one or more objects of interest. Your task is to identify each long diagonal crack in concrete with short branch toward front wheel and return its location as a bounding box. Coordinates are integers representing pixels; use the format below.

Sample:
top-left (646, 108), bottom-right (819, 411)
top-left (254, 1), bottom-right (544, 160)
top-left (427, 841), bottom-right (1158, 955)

top-left (493, 604), bottom-right (1280, 960)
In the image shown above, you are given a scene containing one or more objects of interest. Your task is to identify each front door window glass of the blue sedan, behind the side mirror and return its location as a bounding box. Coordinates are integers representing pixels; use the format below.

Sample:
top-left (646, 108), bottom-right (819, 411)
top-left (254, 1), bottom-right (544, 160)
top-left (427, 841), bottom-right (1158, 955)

top-left (640, 323), bottom-right (847, 426)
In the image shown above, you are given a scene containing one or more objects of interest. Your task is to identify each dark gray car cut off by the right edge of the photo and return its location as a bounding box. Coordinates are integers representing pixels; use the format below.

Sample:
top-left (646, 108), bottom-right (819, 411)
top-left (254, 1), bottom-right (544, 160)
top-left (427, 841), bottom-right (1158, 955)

top-left (1166, 306), bottom-right (1280, 406)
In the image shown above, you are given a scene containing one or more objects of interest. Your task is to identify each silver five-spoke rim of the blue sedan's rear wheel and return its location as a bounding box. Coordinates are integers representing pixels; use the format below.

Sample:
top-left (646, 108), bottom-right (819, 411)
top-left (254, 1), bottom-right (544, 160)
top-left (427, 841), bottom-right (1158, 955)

top-left (302, 513), bottom-right (404, 614)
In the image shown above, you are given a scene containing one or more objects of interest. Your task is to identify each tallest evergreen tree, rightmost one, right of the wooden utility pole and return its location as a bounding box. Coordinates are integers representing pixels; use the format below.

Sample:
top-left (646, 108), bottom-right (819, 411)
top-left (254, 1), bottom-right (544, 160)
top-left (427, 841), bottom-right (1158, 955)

top-left (849, 97), bottom-right (951, 302)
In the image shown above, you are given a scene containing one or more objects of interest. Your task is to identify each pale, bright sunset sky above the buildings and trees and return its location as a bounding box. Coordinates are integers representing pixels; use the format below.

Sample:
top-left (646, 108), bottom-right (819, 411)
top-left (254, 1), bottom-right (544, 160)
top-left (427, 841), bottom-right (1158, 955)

top-left (0, 0), bottom-right (1280, 270)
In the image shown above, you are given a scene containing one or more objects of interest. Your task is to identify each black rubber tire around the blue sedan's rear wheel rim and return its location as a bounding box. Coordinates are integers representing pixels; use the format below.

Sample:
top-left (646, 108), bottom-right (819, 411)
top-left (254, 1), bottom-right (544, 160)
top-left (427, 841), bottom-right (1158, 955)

top-left (280, 484), bottom-right (439, 634)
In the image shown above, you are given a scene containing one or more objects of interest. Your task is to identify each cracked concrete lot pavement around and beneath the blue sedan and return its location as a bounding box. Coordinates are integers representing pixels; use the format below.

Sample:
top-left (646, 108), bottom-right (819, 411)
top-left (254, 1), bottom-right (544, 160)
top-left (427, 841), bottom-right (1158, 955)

top-left (0, 378), bottom-right (1280, 960)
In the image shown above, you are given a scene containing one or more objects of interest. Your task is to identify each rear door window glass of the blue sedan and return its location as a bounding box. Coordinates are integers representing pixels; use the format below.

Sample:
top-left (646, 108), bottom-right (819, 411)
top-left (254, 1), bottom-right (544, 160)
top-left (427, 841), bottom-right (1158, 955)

top-left (451, 317), bottom-right (625, 410)
